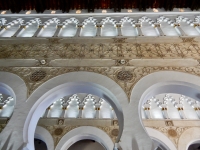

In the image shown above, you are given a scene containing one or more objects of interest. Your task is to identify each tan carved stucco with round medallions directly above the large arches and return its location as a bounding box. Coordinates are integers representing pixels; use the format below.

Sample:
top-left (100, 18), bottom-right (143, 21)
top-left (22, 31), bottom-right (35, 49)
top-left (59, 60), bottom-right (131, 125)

top-left (0, 66), bottom-right (200, 97)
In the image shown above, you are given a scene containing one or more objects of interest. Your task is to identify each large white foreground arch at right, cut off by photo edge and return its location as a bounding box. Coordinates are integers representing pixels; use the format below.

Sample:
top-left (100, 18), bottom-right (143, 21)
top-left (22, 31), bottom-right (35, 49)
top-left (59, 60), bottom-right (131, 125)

top-left (129, 71), bottom-right (200, 149)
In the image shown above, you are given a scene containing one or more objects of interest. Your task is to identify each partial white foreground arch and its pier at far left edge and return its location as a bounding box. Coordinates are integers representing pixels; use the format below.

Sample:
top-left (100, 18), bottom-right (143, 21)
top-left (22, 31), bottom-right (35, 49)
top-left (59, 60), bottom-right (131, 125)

top-left (0, 71), bottom-right (27, 149)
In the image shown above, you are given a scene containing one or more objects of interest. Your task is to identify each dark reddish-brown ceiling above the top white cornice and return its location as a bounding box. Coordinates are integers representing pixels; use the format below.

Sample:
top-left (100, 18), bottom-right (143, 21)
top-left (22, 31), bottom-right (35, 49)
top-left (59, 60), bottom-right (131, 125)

top-left (0, 0), bottom-right (200, 13)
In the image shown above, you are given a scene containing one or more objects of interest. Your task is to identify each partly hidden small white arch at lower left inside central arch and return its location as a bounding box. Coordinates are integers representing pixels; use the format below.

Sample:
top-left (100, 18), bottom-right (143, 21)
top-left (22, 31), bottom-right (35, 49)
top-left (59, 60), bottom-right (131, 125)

top-left (34, 126), bottom-right (54, 150)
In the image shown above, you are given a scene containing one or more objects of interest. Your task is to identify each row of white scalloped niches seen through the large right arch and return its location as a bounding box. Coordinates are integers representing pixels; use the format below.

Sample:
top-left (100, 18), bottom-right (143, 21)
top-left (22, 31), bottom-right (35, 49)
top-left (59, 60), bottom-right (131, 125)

top-left (141, 93), bottom-right (200, 120)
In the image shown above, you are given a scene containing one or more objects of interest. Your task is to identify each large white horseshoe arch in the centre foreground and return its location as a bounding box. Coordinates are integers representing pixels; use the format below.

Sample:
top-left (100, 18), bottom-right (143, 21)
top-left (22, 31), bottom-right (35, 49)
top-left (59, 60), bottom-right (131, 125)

top-left (23, 72), bottom-right (128, 149)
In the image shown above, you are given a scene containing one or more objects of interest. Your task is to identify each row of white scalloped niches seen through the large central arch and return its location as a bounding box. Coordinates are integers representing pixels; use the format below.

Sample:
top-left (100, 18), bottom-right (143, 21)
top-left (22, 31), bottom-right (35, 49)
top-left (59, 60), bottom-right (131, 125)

top-left (43, 93), bottom-right (117, 119)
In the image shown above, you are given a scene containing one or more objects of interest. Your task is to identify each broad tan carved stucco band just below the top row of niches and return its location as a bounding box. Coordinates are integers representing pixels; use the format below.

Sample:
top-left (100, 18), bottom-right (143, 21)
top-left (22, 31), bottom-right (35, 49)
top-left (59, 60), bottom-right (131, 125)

top-left (0, 42), bottom-right (200, 60)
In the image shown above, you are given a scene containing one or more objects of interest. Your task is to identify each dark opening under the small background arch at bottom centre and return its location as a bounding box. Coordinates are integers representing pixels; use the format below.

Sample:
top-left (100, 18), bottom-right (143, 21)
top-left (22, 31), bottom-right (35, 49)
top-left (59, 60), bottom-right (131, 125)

top-left (68, 140), bottom-right (106, 150)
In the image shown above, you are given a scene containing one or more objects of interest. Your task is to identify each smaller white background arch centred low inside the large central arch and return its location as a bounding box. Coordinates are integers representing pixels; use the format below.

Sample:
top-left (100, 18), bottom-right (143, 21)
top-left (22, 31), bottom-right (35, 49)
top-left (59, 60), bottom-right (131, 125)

top-left (56, 126), bottom-right (114, 150)
